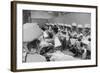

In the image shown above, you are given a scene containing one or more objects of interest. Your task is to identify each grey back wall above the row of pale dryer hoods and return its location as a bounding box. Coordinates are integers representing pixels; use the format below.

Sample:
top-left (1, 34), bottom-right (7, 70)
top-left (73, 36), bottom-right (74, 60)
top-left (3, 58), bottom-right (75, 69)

top-left (31, 12), bottom-right (91, 26)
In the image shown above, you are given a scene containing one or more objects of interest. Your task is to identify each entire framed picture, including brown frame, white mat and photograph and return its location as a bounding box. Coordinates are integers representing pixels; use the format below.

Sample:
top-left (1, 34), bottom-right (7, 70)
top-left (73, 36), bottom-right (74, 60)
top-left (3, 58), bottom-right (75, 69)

top-left (11, 1), bottom-right (97, 71)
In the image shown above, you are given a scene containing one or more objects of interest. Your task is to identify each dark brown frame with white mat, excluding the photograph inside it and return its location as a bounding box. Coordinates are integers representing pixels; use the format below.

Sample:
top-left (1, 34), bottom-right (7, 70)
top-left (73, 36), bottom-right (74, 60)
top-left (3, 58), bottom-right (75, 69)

top-left (11, 1), bottom-right (98, 72)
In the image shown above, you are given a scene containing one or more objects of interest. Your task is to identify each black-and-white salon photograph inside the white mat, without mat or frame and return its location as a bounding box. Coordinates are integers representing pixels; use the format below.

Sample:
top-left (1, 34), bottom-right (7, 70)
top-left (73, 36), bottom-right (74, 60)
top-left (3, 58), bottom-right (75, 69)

top-left (22, 10), bottom-right (91, 62)
